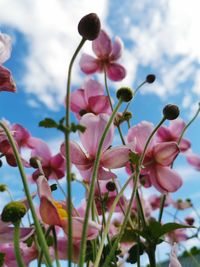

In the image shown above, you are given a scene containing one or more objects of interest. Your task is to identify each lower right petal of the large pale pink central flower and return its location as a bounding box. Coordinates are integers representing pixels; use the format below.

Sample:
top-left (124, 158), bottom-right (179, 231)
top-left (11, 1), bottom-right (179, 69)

top-left (101, 146), bottom-right (130, 169)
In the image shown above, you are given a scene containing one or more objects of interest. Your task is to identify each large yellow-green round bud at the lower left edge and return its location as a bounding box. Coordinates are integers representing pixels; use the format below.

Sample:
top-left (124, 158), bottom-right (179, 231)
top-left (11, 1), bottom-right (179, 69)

top-left (1, 201), bottom-right (27, 224)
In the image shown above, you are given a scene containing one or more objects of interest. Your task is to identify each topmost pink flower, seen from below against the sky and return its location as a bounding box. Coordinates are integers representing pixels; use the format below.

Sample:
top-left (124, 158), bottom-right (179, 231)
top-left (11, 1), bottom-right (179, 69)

top-left (80, 30), bottom-right (126, 81)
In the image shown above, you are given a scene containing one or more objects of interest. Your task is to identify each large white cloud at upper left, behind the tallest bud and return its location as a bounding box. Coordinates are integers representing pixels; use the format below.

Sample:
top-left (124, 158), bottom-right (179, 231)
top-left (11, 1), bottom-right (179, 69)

top-left (0, 0), bottom-right (108, 110)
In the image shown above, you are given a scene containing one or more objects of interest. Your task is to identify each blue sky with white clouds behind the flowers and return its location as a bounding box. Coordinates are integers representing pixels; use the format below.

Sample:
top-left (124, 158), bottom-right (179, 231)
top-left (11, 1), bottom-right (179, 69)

top-left (0, 0), bottom-right (200, 266)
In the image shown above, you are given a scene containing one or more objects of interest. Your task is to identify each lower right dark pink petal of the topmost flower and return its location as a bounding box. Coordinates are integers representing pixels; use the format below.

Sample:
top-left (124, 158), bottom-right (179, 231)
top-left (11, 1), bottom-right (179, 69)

top-left (106, 63), bottom-right (126, 82)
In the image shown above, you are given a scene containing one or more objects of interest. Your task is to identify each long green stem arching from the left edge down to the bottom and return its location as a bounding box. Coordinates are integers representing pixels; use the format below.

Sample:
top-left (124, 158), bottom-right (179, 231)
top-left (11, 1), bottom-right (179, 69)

top-left (0, 121), bottom-right (52, 266)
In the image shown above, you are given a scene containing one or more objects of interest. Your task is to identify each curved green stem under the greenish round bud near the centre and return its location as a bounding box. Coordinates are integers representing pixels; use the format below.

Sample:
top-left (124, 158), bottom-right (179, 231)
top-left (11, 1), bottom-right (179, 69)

top-left (79, 99), bottom-right (122, 267)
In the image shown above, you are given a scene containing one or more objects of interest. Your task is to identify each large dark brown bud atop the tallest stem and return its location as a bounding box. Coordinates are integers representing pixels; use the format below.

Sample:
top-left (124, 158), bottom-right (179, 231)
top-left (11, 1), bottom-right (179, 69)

top-left (78, 13), bottom-right (101, 41)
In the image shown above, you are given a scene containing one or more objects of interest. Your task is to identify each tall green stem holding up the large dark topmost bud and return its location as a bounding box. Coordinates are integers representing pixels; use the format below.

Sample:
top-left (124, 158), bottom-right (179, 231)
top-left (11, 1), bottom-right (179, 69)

top-left (65, 38), bottom-right (86, 267)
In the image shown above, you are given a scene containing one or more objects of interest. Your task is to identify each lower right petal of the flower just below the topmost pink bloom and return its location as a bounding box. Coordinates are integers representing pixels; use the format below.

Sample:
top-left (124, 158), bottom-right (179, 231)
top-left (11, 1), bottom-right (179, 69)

top-left (88, 95), bottom-right (112, 115)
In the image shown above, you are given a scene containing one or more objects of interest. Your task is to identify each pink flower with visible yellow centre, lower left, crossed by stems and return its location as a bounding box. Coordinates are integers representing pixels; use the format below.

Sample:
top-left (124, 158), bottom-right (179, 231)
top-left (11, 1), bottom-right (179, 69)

top-left (37, 176), bottom-right (101, 241)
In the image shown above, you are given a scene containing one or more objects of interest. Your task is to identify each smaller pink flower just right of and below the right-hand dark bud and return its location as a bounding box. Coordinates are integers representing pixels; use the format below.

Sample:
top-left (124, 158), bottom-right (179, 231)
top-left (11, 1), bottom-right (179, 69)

top-left (157, 119), bottom-right (191, 152)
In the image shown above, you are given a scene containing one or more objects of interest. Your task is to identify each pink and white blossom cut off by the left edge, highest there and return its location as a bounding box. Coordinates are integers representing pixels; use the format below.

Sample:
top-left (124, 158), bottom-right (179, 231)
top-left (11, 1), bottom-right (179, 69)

top-left (0, 33), bottom-right (16, 92)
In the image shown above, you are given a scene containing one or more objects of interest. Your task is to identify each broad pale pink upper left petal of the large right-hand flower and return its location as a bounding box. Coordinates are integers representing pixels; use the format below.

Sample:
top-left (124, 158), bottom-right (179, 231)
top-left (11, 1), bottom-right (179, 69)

top-left (127, 121), bottom-right (155, 153)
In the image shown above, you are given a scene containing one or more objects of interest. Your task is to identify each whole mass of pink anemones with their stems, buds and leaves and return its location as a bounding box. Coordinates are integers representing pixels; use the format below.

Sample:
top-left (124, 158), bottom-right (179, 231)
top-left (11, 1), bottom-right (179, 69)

top-left (0, 13), bottom-right (200, 267)
